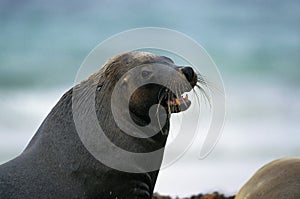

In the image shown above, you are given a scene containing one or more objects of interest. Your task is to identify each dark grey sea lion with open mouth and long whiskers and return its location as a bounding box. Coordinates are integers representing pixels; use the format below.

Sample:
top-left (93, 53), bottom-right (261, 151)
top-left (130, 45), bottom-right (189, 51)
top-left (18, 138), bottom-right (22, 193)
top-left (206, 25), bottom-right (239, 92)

top-left (0, 52), bottom-right (203, 199)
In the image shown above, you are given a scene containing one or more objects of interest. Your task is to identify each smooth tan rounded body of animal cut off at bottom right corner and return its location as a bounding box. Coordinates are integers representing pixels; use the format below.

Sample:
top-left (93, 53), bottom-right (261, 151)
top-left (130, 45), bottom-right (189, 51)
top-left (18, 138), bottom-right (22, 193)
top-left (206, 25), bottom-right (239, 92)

top-left (235, 158), bottom-right (300, 199)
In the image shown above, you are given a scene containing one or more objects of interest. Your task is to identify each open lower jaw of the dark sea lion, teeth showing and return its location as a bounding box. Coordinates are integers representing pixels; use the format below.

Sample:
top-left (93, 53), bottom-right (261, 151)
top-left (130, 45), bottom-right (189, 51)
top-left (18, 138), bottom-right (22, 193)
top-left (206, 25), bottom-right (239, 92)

top-left (166, 94), bottom-right (191, 113)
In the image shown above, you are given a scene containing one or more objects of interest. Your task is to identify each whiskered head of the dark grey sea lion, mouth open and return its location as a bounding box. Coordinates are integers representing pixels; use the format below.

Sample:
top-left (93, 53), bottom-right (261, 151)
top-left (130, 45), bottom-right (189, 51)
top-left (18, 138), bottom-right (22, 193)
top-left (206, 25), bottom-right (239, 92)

top-left (104, 52), bottom-right (204, 126)
